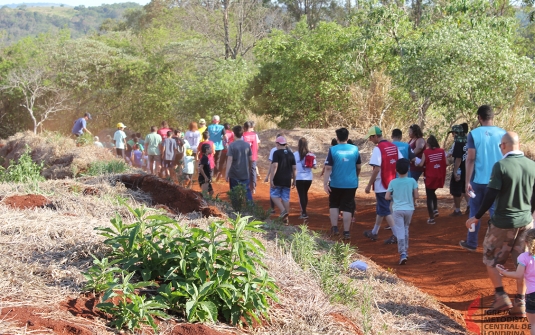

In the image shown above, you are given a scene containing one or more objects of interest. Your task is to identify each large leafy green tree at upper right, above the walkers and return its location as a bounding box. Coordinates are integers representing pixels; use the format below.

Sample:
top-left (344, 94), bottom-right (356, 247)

top-left (397, 16), bottom-right (535, 131)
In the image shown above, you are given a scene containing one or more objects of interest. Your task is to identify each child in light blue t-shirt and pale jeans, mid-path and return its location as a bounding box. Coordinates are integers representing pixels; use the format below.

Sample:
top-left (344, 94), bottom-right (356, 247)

top-left (385, 158), bottom-right (418, 265)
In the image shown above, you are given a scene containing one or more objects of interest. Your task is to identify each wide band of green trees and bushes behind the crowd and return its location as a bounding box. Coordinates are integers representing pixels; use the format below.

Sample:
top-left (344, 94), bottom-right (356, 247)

top-left (0, 0), bottom-right (535, 137)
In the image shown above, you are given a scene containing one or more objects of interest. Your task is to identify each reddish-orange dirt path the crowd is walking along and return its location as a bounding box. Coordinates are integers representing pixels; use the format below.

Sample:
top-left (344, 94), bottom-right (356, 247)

top-left (207, 182), bottom-right (529, 335)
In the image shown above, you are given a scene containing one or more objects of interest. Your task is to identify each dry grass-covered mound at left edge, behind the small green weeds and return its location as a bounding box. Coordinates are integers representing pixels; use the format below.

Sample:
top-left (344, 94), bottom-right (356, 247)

top-left (0, 131), bottom-right (114, 179)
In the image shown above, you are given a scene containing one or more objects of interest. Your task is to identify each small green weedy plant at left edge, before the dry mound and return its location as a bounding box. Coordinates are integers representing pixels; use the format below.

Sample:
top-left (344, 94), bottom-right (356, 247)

top-left (0, 145), bottom-right (45, 183)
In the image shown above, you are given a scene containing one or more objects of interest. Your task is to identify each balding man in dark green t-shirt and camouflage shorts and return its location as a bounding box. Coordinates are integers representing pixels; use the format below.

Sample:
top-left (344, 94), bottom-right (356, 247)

top-left (466, 132), bottom-right (535, 317)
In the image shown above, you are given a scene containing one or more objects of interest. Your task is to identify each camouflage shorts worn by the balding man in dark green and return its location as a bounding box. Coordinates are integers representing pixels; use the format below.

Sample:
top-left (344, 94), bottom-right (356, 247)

top-left (483, 222), bottom-right (533, 267)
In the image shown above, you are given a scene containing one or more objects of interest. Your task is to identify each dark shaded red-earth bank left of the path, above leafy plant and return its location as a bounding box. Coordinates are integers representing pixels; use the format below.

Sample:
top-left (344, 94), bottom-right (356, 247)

top-left (118, 174), bottom-right (224, 217)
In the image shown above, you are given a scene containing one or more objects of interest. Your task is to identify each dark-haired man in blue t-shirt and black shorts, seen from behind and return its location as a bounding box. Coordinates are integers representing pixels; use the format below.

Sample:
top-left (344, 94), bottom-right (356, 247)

top-left (323, 128), bottom-right (361, 239)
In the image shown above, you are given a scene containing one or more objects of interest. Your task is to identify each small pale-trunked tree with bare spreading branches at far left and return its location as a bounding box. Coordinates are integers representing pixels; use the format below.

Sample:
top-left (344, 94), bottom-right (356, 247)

top-left (1, 67), bottom-right (69, 134)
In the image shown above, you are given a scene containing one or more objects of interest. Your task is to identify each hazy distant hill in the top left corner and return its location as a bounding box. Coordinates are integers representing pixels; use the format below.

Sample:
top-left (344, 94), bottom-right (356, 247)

top-left (0, 2), bottom-right (142, 45)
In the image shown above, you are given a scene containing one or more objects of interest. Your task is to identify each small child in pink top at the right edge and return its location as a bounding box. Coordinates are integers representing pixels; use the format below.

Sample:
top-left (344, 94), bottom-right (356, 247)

top-left (496, 228), bottom-right (535, 326)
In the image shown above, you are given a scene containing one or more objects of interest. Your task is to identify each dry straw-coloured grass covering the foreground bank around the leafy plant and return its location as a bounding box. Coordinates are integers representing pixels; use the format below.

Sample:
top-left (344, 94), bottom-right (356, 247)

top-left (0, 178), bottom-right (462, 335)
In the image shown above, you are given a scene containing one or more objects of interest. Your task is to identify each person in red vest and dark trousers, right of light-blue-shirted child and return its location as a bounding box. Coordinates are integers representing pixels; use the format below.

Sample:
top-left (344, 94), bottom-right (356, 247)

top-left (418, 135), bottom-right (446, 224)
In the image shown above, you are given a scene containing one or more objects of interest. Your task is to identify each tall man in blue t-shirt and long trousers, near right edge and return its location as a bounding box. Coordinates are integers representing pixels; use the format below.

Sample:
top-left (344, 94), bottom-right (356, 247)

top-left (459, 105), bottom-right (505, 251)
